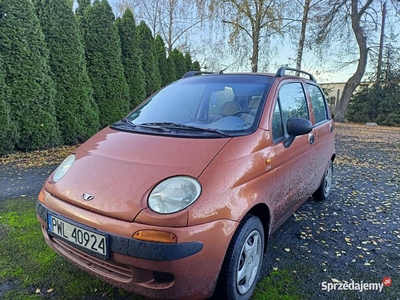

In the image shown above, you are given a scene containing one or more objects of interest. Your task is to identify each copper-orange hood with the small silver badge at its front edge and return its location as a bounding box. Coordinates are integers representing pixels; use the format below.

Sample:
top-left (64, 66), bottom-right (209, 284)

top-left (48, 128), bottom-right (230, 221)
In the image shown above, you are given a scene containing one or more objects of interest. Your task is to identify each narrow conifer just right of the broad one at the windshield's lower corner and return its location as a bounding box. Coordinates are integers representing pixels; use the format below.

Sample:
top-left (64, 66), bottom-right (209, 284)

top-left (116, 8), bottom-right (146, 109)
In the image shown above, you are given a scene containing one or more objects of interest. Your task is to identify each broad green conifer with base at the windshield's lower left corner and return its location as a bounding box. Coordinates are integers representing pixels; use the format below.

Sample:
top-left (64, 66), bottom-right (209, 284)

top-left (81, 0), bottom-right (129, 128)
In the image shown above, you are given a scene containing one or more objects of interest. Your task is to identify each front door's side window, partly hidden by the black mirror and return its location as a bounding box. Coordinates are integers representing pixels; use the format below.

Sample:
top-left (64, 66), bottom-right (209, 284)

top-left (272, 82), bottom-right (310, 141)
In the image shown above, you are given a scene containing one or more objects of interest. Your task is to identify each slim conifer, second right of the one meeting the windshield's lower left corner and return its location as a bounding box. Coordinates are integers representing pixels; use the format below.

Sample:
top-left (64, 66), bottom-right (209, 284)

top-left (137, 21), bottom-right (161, 96)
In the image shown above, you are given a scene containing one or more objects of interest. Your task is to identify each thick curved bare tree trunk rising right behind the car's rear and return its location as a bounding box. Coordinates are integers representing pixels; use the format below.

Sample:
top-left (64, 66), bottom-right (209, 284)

top-left (335, 0), bottom-right (373, 123)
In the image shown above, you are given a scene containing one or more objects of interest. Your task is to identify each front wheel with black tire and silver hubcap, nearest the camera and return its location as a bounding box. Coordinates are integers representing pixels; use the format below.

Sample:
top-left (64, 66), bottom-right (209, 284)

top-left (213, 215), bottom-right (264, 300)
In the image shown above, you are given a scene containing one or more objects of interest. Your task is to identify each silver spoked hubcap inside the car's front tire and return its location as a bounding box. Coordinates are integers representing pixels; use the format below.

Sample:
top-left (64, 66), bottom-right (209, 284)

top-left (236, 230), bottom-right (262, 295)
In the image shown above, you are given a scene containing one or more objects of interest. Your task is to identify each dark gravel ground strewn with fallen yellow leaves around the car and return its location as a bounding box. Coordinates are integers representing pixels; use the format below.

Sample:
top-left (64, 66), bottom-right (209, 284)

top-left (0, 124), bottom-right (400, 300)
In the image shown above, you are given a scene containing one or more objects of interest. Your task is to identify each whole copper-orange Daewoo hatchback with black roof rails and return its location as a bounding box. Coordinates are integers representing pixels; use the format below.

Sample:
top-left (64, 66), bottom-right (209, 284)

top-left (37, 68), bottom-right (335, 299)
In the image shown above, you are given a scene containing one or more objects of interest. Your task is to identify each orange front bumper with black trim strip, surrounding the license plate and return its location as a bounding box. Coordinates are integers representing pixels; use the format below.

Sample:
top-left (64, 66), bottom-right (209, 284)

top-left (37, 193), bottom-right (237, 299)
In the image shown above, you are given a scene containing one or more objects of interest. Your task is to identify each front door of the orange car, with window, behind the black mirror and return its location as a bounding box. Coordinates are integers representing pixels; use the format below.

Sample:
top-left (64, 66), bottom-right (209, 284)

top-left (271, 81), bottom-right (313, 227)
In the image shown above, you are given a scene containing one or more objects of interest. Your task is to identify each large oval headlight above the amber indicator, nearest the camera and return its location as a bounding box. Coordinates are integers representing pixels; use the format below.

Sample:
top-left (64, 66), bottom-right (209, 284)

top-left (148, 176), bottom-right (201, 214)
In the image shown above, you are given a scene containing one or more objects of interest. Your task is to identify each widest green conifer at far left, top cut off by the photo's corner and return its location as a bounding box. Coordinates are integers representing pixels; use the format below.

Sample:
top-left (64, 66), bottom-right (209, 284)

top-left (0, 0), bottom-right (60, 150)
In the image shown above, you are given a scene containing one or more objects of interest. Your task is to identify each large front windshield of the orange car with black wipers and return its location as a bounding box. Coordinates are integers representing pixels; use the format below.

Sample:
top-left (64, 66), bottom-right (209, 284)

top-left (126, 75), bottom-right (272, 135)
